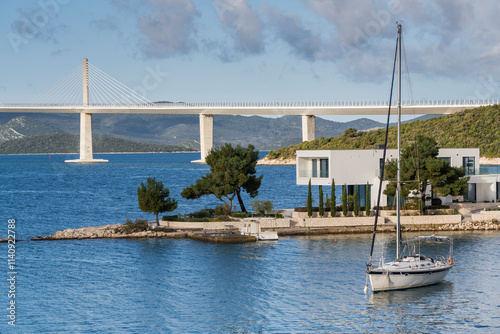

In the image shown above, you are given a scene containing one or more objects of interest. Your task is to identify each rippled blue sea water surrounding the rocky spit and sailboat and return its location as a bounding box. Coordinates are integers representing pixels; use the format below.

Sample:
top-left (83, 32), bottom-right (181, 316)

top-left (0, 153), bottom-right (500, 333)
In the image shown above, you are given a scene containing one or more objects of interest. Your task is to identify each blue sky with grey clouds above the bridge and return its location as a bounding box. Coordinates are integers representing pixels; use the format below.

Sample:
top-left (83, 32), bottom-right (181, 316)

top-left (0, 0), bottom-right (500, 121)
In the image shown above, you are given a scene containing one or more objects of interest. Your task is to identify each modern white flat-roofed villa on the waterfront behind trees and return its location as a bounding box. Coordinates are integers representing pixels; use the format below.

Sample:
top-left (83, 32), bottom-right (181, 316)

top-left (296, 148), bottom-right (500, 207)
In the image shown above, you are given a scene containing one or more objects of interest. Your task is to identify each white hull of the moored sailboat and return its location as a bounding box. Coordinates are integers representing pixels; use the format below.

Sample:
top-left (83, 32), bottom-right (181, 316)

top-left (368, 264), bottom-right (452, 292)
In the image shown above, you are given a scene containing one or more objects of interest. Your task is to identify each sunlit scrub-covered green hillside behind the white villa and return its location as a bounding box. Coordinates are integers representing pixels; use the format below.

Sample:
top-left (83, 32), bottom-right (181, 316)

top-left (268, 105), bottom-right (500, 159)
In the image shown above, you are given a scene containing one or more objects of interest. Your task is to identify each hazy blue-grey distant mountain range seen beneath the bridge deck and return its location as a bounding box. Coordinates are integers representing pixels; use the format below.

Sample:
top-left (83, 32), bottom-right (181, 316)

top-left (0, 113), bottom-right (384, 150)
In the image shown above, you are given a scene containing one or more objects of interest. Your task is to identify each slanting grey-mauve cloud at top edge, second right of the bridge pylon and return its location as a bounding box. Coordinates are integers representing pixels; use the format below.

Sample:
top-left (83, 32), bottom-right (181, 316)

top-left (214, 0), bottom-right (264, 54)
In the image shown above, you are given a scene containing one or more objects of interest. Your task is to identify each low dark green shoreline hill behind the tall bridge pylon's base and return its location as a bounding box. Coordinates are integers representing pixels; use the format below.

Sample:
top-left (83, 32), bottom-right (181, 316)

top-left (0, 133), bottom-right (195, 154)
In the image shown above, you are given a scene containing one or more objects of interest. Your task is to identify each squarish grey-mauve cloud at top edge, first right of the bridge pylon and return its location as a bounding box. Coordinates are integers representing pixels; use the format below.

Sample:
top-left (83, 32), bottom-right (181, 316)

top-left (137, 0), bottom-right (200, 58)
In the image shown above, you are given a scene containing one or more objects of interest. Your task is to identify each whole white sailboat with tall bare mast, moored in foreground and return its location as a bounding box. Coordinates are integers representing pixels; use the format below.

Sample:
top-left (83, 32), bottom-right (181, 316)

top-left (365, 23), bottom-right (453, 292)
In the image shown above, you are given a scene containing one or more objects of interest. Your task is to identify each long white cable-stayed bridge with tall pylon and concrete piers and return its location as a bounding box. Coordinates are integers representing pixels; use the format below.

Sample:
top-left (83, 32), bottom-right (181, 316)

top-left (0, 59), bottom-right (500, 162)
